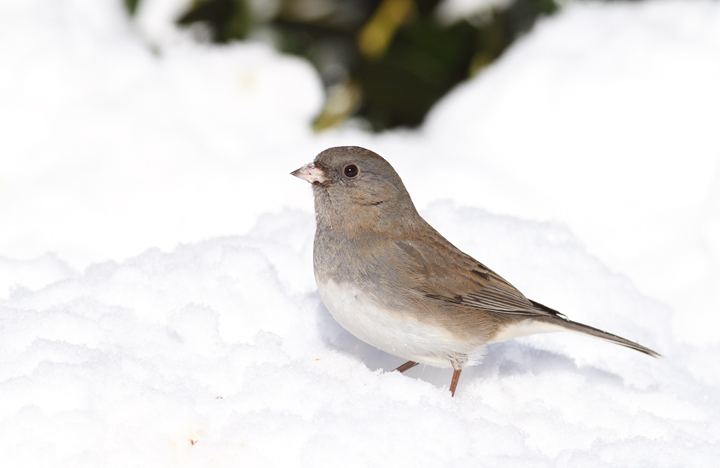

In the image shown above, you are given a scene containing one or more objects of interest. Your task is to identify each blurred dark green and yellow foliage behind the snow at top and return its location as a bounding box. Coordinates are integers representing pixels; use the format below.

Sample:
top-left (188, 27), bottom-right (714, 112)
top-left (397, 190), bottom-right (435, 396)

top-left (125, 0), bottom-right (560, 131)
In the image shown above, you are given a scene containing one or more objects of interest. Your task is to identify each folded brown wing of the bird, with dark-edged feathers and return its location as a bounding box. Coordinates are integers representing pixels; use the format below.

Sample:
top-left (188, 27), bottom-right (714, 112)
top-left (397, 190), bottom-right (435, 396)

top-left (395, 236), bottom-right (562, 317)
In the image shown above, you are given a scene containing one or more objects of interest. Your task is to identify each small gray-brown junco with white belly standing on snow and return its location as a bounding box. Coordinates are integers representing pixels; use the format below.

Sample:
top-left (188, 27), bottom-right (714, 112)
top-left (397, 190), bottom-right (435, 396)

top-left (292, 146), bottom-right (659, 396)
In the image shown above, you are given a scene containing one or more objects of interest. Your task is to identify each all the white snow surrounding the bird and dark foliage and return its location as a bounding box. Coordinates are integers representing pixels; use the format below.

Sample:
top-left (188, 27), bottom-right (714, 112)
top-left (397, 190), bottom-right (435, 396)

top-left (0, 0), bottom-right (720, 468)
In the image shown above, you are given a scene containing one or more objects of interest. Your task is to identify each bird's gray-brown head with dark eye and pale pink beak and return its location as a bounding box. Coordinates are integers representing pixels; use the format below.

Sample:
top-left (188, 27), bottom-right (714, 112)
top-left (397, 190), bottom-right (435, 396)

top-left (292, 146), bottom-right (418, 231)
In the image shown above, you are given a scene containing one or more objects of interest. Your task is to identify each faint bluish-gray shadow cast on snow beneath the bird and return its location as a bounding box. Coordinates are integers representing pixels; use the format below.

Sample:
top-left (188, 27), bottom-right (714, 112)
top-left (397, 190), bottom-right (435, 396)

top-left (317, 302), bottom-right (623, 391)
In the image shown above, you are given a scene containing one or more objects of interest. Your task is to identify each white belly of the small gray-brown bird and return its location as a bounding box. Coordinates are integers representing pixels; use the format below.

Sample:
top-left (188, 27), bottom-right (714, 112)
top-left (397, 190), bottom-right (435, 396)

top-left (316, 278), bottom-right (483, 367)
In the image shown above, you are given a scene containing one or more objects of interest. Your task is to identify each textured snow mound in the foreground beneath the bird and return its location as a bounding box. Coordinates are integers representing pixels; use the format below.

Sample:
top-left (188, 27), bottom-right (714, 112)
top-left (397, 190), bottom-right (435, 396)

top-left (0, 211), bottom-right (720, 467)
